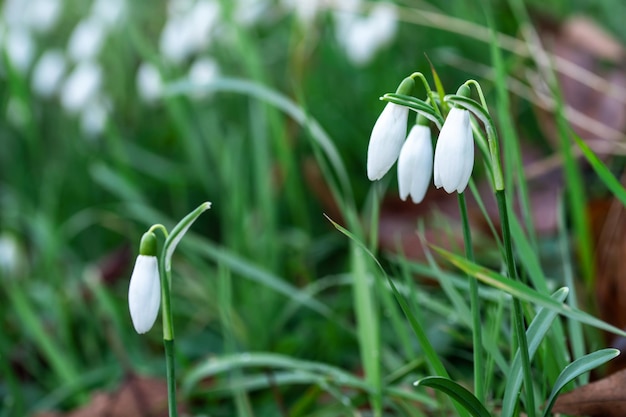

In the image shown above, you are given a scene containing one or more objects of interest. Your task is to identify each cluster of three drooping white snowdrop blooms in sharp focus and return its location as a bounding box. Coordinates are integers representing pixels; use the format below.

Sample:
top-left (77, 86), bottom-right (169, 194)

top-left (367, 78), bottom-right (474, 204)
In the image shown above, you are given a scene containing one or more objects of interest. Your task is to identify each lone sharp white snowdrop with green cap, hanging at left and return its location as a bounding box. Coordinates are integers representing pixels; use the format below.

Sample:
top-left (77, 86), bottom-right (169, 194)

top-left (128, 232), bottom-right (161, 334)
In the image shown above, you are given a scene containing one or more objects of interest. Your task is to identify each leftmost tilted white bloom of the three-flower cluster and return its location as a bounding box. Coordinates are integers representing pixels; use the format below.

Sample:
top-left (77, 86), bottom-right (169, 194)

top-left (367, 103), bottom-right (409, 181)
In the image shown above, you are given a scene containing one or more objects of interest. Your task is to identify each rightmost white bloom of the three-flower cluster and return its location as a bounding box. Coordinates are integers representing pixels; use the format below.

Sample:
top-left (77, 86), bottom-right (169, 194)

top-left (434, 108), bottom-right (474, 193)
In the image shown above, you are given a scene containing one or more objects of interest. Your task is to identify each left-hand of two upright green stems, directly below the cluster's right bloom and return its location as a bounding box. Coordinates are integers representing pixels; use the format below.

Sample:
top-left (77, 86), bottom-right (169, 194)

top-left (458, 193), bottom-right (485, 403)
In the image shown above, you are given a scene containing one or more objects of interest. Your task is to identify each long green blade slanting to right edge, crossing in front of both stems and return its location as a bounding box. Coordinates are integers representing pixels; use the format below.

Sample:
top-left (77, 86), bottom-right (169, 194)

top-left (434, 247), bottom-right (626, 337)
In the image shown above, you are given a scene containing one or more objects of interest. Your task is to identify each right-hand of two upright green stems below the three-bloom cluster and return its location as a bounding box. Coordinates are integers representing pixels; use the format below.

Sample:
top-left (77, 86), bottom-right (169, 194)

top-left (496, 189), bottom-right (535, 417)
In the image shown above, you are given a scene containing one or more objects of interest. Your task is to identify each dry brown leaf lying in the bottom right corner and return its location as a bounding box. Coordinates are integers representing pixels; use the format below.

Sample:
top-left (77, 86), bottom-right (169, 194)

top-left (553, 370), bottom-right (626, 417)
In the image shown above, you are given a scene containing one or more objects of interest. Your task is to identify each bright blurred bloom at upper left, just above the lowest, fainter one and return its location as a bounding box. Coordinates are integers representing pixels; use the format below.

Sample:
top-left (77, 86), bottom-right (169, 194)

top-left (61, 61), bottom-right (102, 114)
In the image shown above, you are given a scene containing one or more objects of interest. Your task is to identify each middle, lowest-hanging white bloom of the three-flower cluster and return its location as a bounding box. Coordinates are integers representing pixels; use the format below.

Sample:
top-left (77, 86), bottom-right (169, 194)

top-left (398, 124), bottom-right (433, 204)
